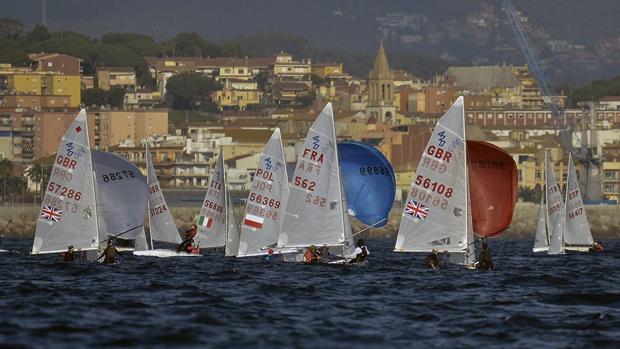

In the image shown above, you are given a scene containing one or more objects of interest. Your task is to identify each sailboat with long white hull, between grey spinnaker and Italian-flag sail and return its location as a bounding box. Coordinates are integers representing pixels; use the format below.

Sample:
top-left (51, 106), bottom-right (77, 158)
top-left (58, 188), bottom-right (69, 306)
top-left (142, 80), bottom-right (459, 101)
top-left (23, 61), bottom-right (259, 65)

top-left (133, 142), bottom-right (198, 257)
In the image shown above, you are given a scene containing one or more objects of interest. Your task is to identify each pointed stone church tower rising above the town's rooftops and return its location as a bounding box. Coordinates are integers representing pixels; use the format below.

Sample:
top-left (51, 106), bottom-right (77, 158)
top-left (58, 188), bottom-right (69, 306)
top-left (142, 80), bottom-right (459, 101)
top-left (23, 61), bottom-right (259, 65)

top-left (366, 39), bottom-right (396, 121)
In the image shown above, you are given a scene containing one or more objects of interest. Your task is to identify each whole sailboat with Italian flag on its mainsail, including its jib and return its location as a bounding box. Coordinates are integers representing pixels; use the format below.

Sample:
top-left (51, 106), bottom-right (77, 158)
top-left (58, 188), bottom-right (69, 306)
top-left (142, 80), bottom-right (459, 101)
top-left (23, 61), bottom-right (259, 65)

top-left (194, 149), bottom-right (239, 256)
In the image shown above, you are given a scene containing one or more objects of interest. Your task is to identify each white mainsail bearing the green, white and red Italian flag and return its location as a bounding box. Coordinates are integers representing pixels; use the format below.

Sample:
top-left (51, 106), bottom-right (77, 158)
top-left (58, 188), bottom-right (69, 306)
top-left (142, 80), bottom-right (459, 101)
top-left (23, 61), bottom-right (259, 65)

top-left (194, 150), bottom-right (227, 248)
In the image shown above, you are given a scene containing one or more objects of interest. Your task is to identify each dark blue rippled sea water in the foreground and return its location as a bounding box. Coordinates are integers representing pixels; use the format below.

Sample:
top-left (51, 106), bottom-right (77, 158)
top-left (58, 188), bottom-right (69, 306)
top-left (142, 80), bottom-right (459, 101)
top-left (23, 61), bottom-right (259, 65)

top-left (0, 240), bottom-right (620, 348)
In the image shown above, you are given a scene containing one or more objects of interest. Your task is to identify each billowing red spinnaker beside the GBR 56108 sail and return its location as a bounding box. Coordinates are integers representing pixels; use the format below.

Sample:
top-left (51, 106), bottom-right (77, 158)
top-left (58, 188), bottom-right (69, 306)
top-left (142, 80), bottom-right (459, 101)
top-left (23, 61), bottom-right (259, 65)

top-left (467, 141), bottom-right (518, 237)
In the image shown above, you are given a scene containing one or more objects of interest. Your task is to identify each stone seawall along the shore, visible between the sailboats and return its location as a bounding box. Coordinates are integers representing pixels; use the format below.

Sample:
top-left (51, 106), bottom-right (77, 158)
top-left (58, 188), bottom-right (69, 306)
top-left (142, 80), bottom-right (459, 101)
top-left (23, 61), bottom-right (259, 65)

top-left (0, 203), bottom-right (620, 240)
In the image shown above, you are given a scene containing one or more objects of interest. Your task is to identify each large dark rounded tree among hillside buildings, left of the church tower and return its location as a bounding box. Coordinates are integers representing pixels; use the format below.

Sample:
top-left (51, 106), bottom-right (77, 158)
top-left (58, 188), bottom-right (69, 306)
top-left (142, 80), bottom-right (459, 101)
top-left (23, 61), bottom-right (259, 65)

top-left (166, 73), bottom-right (222, 110)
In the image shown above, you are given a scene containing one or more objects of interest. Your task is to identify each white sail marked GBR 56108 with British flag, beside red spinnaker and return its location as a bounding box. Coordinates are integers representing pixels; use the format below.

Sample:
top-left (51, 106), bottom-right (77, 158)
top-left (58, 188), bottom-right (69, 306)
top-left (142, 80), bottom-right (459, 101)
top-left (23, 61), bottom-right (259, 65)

top-left (395, 97), bottom-right (473, 263)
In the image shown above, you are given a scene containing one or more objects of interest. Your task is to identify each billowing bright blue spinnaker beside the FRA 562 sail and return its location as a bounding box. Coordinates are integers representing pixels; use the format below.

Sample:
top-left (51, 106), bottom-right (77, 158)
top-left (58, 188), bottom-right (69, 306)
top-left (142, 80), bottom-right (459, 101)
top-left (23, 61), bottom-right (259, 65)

top-left (338, 142), bottom-right (396, 227)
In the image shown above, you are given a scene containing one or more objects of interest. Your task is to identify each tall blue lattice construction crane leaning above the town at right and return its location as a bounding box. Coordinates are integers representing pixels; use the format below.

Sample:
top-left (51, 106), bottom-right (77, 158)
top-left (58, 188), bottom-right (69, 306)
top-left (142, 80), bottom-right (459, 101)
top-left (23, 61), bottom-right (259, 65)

top-left (501, 0), bottom-right (601, 200)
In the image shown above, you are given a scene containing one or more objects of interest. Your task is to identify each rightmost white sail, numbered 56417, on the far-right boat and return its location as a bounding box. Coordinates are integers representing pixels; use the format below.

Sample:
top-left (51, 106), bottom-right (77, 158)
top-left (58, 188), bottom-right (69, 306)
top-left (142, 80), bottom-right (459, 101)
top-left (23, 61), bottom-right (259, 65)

top-left (564, 154), bottom-right (594, 247)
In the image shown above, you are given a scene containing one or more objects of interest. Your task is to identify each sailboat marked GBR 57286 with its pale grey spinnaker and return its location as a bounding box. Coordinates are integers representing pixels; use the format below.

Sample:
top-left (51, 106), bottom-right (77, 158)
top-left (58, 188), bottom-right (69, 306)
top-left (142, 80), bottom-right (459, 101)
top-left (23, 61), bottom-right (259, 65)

top-left (32, 109), bottom-right (146, 256)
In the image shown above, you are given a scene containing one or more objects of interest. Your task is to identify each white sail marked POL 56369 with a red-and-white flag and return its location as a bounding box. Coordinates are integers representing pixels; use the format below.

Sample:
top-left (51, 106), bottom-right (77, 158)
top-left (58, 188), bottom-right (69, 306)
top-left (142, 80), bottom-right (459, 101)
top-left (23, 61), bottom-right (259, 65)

top-left (237, 128), bottom-right (289, 257)
